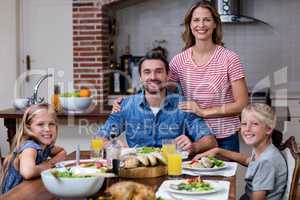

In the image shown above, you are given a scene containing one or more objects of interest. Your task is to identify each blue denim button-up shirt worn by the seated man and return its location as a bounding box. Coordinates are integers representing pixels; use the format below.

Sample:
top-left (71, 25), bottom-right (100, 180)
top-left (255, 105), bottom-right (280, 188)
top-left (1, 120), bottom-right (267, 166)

top-left (97, 92), bottom-right (212, 147)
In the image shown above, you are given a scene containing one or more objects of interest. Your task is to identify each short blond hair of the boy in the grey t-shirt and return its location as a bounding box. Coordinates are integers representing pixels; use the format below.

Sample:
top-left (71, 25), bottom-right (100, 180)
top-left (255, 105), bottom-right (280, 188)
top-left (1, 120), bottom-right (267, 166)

top-left (242, 103), bottom-right (276, 129)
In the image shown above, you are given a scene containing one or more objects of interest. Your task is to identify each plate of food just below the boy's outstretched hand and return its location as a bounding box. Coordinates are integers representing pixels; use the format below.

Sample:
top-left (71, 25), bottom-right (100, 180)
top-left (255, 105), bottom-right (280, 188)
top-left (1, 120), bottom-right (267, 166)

top-left (182, 156), bottom-right (227, 171)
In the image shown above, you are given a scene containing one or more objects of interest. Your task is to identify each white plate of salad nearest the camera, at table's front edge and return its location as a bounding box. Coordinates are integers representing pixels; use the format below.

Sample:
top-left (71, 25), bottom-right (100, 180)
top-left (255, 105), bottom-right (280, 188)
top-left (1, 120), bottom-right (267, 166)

top-left (167, 177), bottom-right (221, 195)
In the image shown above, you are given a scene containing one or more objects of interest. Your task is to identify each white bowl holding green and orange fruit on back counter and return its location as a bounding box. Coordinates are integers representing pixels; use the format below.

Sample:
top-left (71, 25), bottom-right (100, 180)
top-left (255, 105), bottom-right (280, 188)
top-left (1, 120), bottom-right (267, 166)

top-left (59, 97), bottom-right (93, 111)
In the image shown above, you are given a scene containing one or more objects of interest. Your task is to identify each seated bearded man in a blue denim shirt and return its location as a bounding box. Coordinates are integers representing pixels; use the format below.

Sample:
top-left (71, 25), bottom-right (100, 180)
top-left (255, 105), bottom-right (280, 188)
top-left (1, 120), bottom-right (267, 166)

top-left (98, 51), bottom-right (216, 153)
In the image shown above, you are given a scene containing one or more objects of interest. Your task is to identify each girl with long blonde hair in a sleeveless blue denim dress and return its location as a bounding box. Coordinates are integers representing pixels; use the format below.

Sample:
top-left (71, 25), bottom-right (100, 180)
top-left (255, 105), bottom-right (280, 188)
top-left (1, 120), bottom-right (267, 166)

top-left (1, 104), bottom-right (66, 193)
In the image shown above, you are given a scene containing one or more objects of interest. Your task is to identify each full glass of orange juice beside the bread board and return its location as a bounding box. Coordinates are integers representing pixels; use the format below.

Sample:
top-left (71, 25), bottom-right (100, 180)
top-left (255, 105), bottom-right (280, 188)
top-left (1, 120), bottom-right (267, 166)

top-left (168, 152), bottom-right (182, 177)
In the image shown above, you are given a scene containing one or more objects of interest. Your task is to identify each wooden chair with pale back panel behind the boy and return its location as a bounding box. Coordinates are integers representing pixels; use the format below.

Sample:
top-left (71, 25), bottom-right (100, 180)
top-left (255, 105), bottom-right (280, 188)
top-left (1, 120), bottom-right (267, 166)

top-left (279, 136), bottom-right (300, 200)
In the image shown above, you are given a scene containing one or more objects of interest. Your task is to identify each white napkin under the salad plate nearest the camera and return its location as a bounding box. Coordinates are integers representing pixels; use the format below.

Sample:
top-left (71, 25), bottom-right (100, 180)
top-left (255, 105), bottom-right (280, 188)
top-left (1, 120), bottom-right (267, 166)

top-left (156, 180), bottom-right (230, 200)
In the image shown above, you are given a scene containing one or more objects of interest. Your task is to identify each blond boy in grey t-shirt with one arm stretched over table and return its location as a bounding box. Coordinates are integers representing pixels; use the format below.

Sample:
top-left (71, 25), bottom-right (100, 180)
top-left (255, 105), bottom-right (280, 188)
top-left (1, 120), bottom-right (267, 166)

top-left (194, 104), bottom-right (287, 200)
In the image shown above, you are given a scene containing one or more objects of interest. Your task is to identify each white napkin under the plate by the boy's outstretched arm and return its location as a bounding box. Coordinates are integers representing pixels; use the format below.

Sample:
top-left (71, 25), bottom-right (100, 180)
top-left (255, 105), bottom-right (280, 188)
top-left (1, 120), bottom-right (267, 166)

top-left (182, 162), bottom-right (238, 177)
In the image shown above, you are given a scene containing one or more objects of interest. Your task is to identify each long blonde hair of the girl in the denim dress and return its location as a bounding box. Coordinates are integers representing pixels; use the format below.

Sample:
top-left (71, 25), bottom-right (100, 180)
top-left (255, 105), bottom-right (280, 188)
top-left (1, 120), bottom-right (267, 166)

top-left (0, 104), bottom-right (58, 190)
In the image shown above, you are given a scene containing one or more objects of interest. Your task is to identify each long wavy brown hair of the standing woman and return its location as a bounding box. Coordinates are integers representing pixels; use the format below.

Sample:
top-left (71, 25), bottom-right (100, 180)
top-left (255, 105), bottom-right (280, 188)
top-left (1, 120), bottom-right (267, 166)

top-left (181, 0), bottom-right (223, 50)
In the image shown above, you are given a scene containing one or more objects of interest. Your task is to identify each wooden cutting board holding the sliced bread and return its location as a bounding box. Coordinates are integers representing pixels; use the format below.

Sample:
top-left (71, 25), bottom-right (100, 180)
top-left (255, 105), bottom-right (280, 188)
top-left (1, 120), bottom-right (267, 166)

top-left (119, 165), bottom-right (168, 178)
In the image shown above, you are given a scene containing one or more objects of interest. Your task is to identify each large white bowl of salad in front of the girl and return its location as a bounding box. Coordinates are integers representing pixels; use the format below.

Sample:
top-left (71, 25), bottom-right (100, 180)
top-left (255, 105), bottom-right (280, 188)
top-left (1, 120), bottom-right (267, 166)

top-left (41, 167), bottom-right (105, 198)
